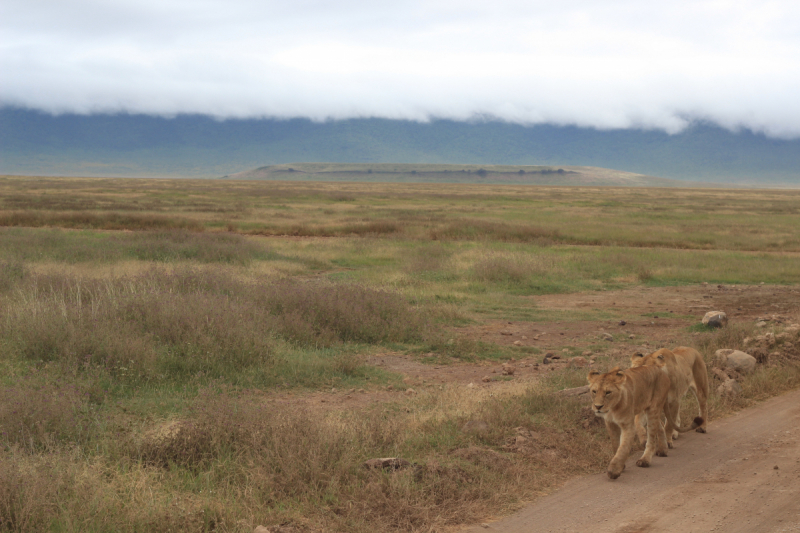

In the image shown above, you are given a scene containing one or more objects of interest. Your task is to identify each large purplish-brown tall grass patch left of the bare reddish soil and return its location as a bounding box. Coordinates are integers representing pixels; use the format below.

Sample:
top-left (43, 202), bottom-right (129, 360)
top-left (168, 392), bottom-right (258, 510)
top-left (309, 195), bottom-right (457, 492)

top-left (0, 269), bottom-right (427, 380)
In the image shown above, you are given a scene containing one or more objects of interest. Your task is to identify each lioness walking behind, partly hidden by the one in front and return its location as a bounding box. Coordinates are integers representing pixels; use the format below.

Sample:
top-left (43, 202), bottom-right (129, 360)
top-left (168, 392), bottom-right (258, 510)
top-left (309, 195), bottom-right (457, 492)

top-left (631, 346), bottom-right (708, 448)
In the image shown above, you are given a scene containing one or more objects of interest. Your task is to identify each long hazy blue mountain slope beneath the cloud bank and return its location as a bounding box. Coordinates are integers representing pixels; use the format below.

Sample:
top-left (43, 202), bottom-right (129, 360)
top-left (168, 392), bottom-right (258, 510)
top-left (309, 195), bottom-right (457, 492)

top-left (0, 108), bottom-right (800, 186)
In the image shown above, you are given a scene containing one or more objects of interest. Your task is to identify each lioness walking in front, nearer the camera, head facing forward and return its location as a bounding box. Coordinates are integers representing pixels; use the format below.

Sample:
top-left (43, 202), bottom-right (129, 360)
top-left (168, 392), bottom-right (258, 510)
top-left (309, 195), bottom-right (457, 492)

top-left (587, 365), bottom-right (703, 479)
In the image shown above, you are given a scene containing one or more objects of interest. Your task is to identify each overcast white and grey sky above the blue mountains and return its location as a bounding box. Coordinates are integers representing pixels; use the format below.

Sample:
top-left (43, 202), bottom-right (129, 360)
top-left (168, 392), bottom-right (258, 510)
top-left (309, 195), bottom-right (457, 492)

top-left (0, 0), bottom-right (800, 138)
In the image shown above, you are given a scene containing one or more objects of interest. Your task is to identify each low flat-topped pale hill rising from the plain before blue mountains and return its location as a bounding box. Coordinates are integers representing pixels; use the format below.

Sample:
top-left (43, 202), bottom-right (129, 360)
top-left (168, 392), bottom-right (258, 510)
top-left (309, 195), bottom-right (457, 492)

top-left (224, 163), bottom-right (701, 187)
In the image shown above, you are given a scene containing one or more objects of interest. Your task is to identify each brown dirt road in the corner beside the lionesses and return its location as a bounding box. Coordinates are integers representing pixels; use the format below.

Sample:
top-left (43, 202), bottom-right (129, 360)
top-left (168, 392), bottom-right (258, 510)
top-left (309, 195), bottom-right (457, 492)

top-left (465, 391), bottom-right (800, 533)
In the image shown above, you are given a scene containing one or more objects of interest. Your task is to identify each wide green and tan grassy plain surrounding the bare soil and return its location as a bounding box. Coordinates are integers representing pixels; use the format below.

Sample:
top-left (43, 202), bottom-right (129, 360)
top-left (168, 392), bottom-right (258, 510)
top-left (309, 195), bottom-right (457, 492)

top-left (0, 177), bottom-right (800, 531)
